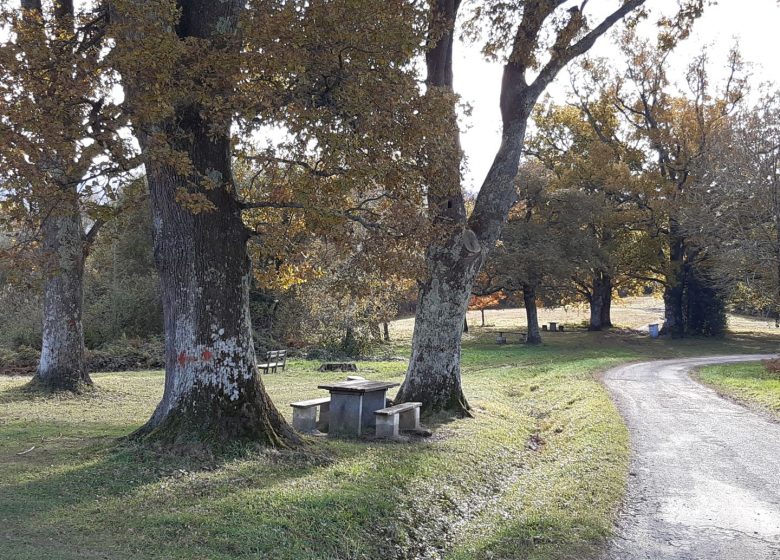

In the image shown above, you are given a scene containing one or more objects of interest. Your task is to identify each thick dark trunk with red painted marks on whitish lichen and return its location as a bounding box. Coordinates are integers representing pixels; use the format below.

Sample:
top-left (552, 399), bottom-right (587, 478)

top-left (123, 0), bottom-right (300, 446)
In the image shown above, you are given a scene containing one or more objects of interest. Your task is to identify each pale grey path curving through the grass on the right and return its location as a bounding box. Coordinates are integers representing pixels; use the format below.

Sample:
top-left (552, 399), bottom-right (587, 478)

top-left (603, 355), bottom-right (780, 560)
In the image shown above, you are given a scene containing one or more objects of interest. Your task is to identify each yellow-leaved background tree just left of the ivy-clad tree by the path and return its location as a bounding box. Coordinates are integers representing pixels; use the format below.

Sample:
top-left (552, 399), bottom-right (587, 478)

top-left (528, 98), bottom-right (657, 331)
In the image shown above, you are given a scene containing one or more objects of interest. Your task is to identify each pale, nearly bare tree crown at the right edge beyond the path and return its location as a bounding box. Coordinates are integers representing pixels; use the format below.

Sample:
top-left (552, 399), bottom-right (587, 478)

top-left (682, 92), bottom-right (780, 328)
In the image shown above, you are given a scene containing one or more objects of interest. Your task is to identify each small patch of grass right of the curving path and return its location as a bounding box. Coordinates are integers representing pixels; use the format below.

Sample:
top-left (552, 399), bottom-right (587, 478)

top-left (696, 363), bottom-right (780, 420)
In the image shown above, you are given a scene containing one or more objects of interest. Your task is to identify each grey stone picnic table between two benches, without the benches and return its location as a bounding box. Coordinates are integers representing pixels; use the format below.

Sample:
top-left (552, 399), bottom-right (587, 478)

top-left (318, 380), bottom-right (400, 437)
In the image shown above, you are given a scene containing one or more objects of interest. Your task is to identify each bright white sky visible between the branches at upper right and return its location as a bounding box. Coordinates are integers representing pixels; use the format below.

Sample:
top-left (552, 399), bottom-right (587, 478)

top-left (454, 0), bottom-right (780, 192)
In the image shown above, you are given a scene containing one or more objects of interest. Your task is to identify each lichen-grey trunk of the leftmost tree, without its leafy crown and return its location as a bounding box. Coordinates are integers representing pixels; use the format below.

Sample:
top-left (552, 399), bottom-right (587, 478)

top-left (33, 192), bottom-right (92, 392)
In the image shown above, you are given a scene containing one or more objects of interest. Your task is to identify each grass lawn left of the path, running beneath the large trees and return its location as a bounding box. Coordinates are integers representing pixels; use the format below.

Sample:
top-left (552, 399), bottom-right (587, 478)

top-left (0, 316), bottom-right (775, 560)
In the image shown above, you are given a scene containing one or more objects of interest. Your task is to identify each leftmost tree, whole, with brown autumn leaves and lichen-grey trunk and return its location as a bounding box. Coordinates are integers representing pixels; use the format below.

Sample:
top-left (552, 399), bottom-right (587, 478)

top-left (0, 0), bottom-right (133, 391)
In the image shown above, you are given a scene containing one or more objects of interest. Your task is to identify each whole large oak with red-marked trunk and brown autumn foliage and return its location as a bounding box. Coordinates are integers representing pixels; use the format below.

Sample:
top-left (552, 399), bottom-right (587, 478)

top-left (110, 0), bottom-right (439, 446)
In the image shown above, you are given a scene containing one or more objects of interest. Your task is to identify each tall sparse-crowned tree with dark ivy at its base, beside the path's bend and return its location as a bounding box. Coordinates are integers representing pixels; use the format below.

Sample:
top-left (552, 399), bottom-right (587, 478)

top-left (614, 34), bottom-right (744, 337)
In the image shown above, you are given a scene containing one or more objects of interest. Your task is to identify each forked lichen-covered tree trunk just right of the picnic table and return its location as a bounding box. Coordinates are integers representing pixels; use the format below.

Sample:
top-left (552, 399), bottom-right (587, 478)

top-left (396, 0), bottom-right (537, 415)
